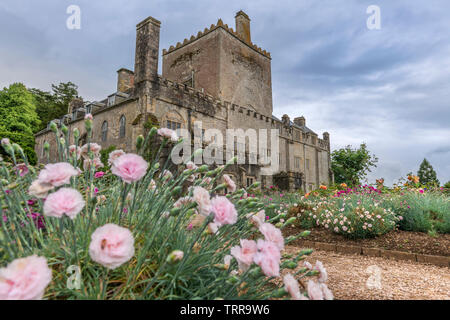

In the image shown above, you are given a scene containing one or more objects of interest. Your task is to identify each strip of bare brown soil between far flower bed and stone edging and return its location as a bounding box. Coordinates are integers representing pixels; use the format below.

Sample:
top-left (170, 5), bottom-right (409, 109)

top-left (283, 226), bottom-right (450, 257)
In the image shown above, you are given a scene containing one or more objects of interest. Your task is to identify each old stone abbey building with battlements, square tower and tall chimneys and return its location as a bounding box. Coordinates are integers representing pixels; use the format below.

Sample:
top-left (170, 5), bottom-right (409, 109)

top-left (35, 11), bottom-right (333, 191)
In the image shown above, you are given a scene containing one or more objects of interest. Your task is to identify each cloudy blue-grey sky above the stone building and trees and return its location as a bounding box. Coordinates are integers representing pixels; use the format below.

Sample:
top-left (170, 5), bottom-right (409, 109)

top-left (0, 0), bottom-right (450, 183)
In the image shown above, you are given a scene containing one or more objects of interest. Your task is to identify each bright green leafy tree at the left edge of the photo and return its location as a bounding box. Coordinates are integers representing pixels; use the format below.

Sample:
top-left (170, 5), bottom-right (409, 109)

top-left (0, 83), bottom-right (40, 164)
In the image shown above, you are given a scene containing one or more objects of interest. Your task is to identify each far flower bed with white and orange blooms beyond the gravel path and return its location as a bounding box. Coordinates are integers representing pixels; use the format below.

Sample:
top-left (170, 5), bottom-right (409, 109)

top-left (289, 181), bottom-right (450, 238)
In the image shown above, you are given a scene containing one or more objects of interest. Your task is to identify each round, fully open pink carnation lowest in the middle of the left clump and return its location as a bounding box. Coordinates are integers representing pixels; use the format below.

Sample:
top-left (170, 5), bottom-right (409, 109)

top-left (89, 223), bottom-right (134, 269)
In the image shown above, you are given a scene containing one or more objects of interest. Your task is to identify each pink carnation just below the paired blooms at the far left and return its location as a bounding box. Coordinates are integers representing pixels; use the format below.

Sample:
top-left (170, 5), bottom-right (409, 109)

top-left (44, 188), bottom-right (85, 219)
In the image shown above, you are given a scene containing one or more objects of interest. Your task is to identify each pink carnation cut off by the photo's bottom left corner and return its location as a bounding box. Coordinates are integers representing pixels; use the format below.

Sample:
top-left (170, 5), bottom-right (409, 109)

top-left (0, 255), bottom-right (52, 300)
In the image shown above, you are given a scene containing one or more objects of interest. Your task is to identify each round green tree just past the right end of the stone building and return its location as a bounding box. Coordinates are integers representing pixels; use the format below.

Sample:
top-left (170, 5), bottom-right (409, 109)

top-left (331, 143), bottom-right (378, 185)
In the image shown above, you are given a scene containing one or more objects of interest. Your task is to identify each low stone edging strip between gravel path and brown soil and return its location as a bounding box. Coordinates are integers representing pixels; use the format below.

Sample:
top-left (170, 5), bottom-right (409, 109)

top-left (297, 240), bottom-right (450, 268)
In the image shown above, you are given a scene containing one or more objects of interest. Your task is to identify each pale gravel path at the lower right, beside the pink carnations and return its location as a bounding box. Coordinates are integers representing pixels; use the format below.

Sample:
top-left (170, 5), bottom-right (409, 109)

top-left (286, 246), bottom-right (450, 300)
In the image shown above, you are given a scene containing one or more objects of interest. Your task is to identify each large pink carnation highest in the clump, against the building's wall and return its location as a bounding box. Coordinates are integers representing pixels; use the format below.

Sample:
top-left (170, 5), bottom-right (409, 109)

top-left (111, 153), bottom-right (148, 183)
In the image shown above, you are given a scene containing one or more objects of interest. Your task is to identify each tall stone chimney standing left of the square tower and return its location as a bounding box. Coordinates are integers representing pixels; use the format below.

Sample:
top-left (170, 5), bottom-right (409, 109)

top-left (134, 17), bottom-right (161, 84)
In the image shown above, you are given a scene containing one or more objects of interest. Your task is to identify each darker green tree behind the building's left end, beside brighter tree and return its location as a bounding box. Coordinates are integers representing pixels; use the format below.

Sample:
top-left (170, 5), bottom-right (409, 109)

top-left (29, 81), bottom-right (79, 132)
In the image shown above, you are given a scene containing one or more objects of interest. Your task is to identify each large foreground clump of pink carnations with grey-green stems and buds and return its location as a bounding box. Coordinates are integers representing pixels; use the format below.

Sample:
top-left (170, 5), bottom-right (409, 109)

top-left (0, 116), bottom-right (332, 300)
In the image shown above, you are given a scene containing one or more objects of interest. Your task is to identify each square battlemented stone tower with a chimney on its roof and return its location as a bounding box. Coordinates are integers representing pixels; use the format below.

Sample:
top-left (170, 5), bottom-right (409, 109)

top-left (162, 11), bottom-right (273, 116)
